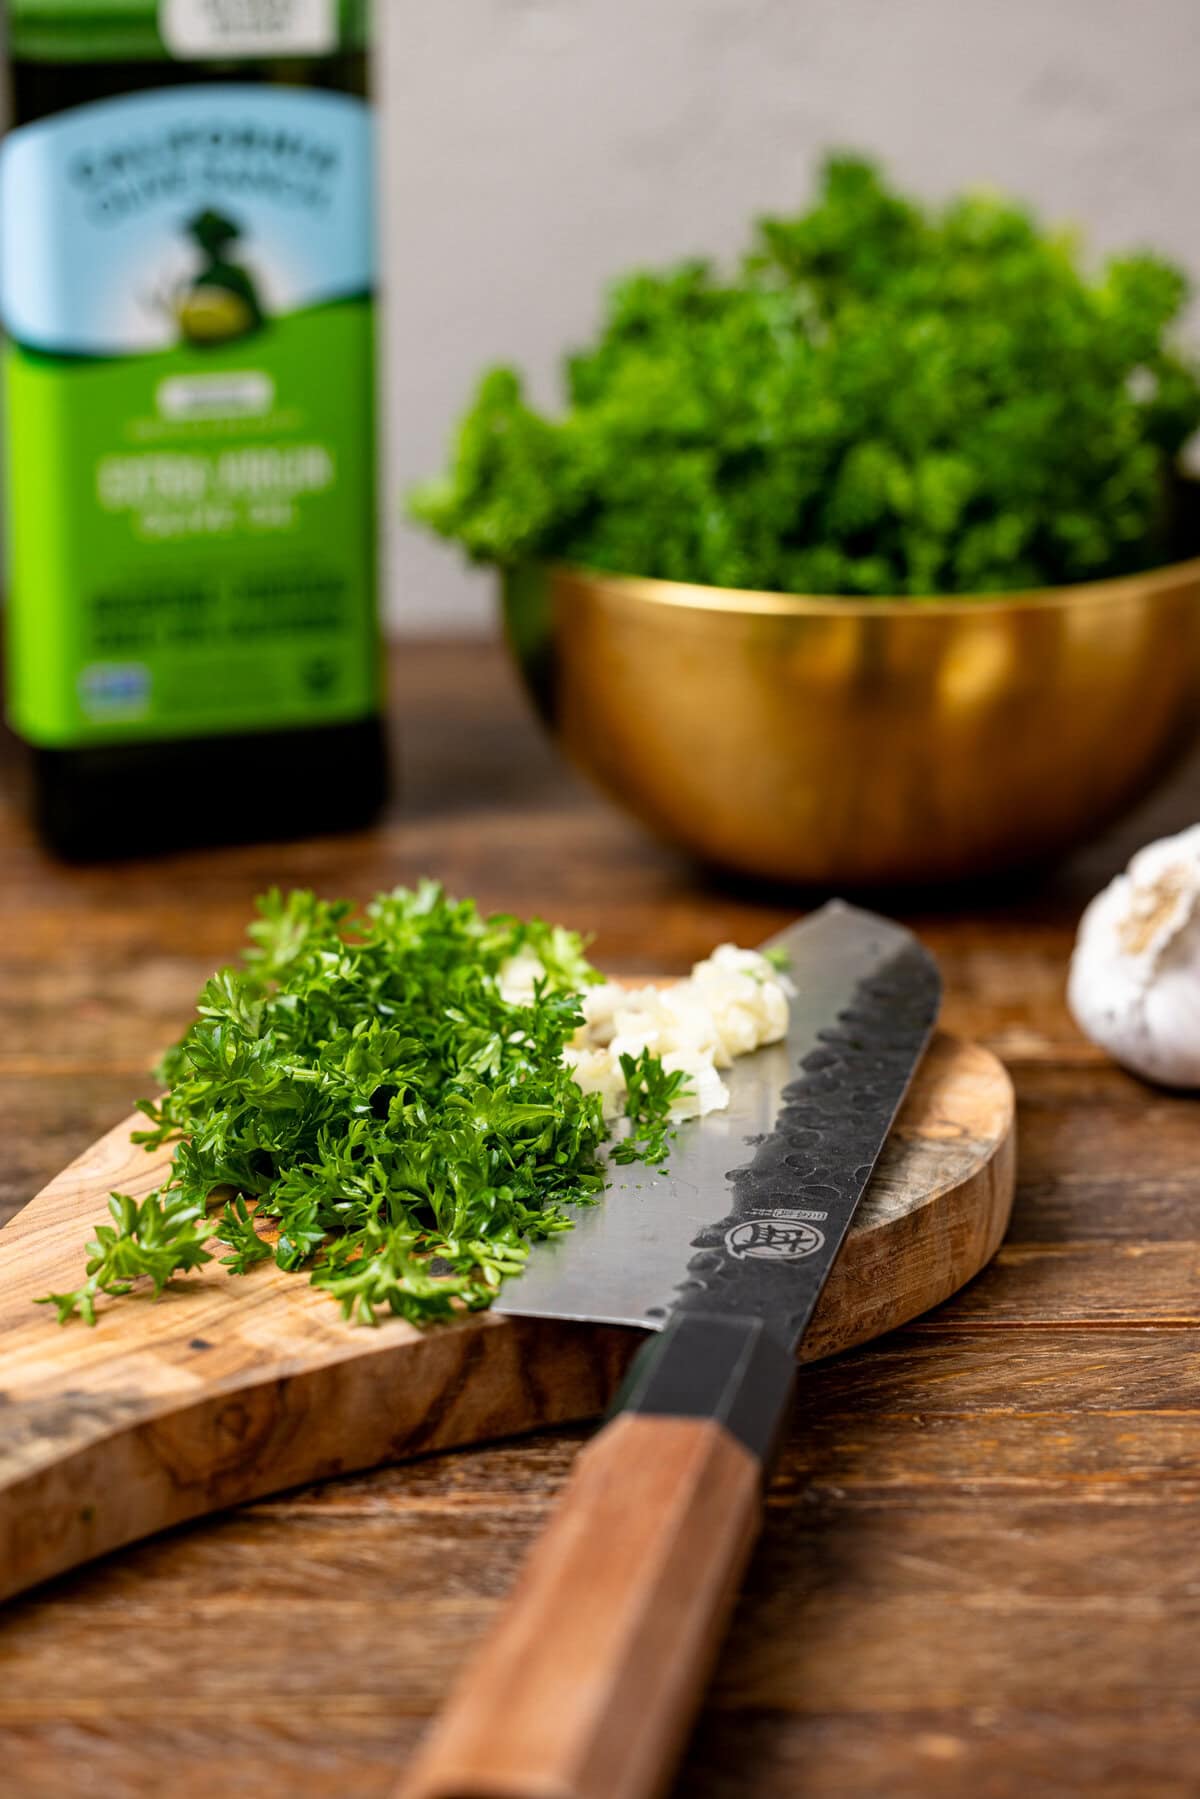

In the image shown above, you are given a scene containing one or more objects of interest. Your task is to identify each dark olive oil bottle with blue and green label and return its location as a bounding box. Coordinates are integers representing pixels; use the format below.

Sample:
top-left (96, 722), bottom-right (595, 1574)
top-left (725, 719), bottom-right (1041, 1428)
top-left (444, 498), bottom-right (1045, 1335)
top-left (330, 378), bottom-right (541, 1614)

top-left (0, 0), bottom-right (385, 858)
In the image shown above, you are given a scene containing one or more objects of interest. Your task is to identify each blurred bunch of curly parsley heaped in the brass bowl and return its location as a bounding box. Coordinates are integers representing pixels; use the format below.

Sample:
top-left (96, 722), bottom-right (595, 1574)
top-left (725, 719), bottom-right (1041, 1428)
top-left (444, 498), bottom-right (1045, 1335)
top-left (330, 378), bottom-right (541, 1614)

top-left (412, 157), bottom-right (1200, 595)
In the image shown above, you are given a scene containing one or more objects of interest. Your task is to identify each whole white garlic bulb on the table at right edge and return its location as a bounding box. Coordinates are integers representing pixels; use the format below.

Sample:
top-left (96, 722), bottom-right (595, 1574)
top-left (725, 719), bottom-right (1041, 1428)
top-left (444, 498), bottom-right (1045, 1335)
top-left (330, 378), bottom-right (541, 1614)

top-left (1067, 824), bottom-right (1200, 1087)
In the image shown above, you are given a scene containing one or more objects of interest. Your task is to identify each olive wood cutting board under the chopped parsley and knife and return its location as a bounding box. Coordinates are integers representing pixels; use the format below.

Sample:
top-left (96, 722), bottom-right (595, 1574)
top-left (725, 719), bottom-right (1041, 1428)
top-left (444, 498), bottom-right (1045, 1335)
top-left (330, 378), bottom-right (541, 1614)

top-left (0, 1034), bottom-right (1015, 1596)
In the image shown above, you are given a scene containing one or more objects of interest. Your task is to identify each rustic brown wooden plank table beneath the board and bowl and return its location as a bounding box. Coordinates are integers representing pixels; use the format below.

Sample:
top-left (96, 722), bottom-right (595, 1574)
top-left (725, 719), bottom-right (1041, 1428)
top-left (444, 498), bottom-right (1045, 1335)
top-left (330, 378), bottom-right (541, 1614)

top-left (0, 644), bottom-right (1200, 1799)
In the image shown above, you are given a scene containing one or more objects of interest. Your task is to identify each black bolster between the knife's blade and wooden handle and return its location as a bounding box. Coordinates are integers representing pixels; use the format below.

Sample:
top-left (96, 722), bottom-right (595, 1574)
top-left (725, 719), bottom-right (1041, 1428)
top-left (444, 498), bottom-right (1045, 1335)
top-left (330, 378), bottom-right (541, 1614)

top-left (613, 1311), bottom-right (795, 1468)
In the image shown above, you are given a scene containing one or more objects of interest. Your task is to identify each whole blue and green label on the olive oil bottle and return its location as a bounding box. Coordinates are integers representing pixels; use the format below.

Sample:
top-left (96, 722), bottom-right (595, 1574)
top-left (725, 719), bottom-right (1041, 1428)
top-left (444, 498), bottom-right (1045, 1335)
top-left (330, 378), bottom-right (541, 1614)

top-left (0, 85), bottom-right (378, 747)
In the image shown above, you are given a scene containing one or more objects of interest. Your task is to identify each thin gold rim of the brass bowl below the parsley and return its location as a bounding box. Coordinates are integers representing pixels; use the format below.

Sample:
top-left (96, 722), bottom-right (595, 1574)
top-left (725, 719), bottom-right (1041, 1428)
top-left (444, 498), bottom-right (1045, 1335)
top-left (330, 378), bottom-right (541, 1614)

top-left (547, 556), bottom-right (1200, 619)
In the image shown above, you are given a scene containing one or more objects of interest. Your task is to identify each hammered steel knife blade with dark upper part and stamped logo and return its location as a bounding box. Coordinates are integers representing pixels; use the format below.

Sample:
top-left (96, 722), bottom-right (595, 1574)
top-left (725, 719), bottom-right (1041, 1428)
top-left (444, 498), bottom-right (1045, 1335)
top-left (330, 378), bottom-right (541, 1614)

top-left (493, 901), bottom-right (939, 1346)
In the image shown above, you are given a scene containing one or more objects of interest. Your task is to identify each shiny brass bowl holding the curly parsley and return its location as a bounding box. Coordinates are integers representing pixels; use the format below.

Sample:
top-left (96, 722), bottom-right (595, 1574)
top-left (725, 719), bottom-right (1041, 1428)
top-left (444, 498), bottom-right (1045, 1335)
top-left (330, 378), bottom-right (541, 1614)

top-left (504, 558), bottom-right (1200, 887)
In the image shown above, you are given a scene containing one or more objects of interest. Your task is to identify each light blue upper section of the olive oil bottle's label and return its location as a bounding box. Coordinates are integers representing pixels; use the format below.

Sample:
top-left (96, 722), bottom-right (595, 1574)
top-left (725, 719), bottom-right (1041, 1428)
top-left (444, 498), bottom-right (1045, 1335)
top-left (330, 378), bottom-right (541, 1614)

top-left (0, 83), bottom-right (374, 356)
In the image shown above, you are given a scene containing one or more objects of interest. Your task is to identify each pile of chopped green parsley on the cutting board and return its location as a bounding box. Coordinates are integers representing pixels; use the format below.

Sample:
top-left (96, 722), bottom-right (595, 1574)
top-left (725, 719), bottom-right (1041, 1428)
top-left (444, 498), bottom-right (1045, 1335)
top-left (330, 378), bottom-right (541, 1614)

top-left (41, 882), bottom-right (684, 1324)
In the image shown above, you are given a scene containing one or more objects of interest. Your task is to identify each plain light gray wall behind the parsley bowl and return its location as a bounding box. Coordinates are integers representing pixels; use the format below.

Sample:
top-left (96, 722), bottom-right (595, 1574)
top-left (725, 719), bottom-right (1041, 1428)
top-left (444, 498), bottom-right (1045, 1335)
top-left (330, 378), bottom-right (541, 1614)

top-left (378, 0), bottom-right (1200, 631)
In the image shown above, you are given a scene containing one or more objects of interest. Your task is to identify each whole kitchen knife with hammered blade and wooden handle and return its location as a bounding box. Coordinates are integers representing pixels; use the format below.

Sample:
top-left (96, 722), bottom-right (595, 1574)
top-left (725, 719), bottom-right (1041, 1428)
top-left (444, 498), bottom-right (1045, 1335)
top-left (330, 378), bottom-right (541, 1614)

top-left (399, 903), bottom-right (941, 1799)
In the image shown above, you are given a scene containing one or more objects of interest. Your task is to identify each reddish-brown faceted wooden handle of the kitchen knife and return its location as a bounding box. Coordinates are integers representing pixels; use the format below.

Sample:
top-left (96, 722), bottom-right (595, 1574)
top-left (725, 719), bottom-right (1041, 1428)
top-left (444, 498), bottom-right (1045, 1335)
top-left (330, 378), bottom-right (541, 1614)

top-left (399, 1412), bottom-right (761, 1799)
